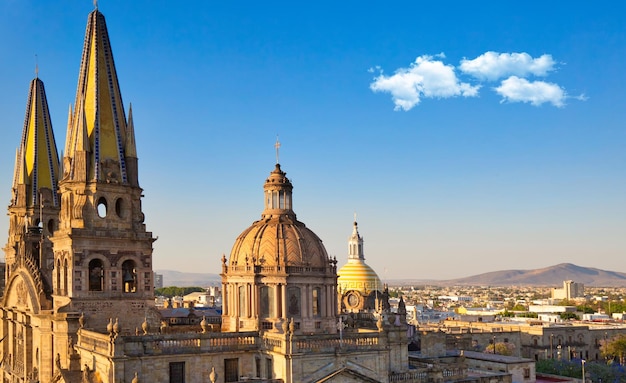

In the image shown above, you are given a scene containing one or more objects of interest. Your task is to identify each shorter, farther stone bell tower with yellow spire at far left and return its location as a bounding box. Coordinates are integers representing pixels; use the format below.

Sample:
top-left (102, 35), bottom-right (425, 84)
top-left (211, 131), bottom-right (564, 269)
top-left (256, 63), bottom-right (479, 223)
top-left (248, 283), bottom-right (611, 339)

top-left (4, 74), bottom-right (59, 310)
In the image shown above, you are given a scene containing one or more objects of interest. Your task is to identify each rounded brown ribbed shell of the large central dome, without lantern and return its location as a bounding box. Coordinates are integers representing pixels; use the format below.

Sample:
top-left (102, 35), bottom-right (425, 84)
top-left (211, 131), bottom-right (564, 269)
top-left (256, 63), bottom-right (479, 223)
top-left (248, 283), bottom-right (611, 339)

top-left (230, 217), bottom-right (328, 267)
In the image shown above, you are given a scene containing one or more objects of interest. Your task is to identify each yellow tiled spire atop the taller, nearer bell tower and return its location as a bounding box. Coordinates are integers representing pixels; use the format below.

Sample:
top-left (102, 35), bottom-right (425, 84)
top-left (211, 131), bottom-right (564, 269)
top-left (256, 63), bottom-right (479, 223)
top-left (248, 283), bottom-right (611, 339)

top-left (65, 8), bottom-right (137, 185)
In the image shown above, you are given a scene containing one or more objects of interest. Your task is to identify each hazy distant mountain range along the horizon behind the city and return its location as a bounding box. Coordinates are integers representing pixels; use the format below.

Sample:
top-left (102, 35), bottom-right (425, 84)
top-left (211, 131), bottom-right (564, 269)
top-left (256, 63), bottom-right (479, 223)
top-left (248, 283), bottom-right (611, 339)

top-left (156, 263), bottom-right (626, 288)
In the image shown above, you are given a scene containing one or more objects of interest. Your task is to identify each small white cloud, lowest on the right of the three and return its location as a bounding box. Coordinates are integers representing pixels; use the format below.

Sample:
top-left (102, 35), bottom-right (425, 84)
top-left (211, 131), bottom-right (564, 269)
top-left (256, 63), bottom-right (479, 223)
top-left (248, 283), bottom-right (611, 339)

top-left (494, 76), bottom-right (567, 107)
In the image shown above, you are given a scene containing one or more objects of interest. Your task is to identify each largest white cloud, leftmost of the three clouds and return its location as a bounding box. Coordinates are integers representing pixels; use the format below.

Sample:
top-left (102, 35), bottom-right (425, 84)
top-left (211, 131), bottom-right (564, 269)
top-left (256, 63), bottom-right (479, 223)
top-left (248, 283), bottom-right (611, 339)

top-left (370, 54), bottom-right (480, 111)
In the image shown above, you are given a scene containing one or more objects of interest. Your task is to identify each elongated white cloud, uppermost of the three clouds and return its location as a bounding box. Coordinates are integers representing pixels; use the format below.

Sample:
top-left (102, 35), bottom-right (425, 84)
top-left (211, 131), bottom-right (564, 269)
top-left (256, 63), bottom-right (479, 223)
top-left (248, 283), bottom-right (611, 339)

top-left (459, 51), bottom-right (556, 81)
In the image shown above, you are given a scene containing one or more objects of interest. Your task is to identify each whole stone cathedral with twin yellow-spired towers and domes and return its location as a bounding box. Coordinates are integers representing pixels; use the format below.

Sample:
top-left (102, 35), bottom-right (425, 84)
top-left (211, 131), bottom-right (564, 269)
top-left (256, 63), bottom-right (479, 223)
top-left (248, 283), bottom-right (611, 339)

top-left (0, 8), bottom-right (425, 383)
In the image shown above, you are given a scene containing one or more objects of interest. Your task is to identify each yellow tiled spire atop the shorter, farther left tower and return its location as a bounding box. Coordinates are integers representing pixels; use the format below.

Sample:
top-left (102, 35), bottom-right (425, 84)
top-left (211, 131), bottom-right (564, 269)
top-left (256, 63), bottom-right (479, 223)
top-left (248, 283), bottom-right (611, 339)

top-left (13, 78), bottom-right (59, 207)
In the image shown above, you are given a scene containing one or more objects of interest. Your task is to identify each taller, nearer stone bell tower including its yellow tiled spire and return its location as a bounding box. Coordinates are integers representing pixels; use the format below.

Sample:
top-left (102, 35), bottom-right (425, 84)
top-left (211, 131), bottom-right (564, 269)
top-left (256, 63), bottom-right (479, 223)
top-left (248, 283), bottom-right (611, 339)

top-left (52, 9), bottom-right (154, 328)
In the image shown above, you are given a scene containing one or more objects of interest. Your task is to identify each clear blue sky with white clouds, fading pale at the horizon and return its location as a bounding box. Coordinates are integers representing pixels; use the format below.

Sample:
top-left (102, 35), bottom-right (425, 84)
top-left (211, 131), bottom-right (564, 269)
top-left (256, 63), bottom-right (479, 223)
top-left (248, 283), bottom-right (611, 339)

top-left (0, 0), bottom-right (626, 285)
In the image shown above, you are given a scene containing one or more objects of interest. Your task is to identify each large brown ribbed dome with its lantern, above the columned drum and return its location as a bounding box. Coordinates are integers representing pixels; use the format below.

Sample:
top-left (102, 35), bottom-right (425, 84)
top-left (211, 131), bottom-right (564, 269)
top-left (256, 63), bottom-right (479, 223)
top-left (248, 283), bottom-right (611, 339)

top-left (229, 164), bottom-right (329, 272)
